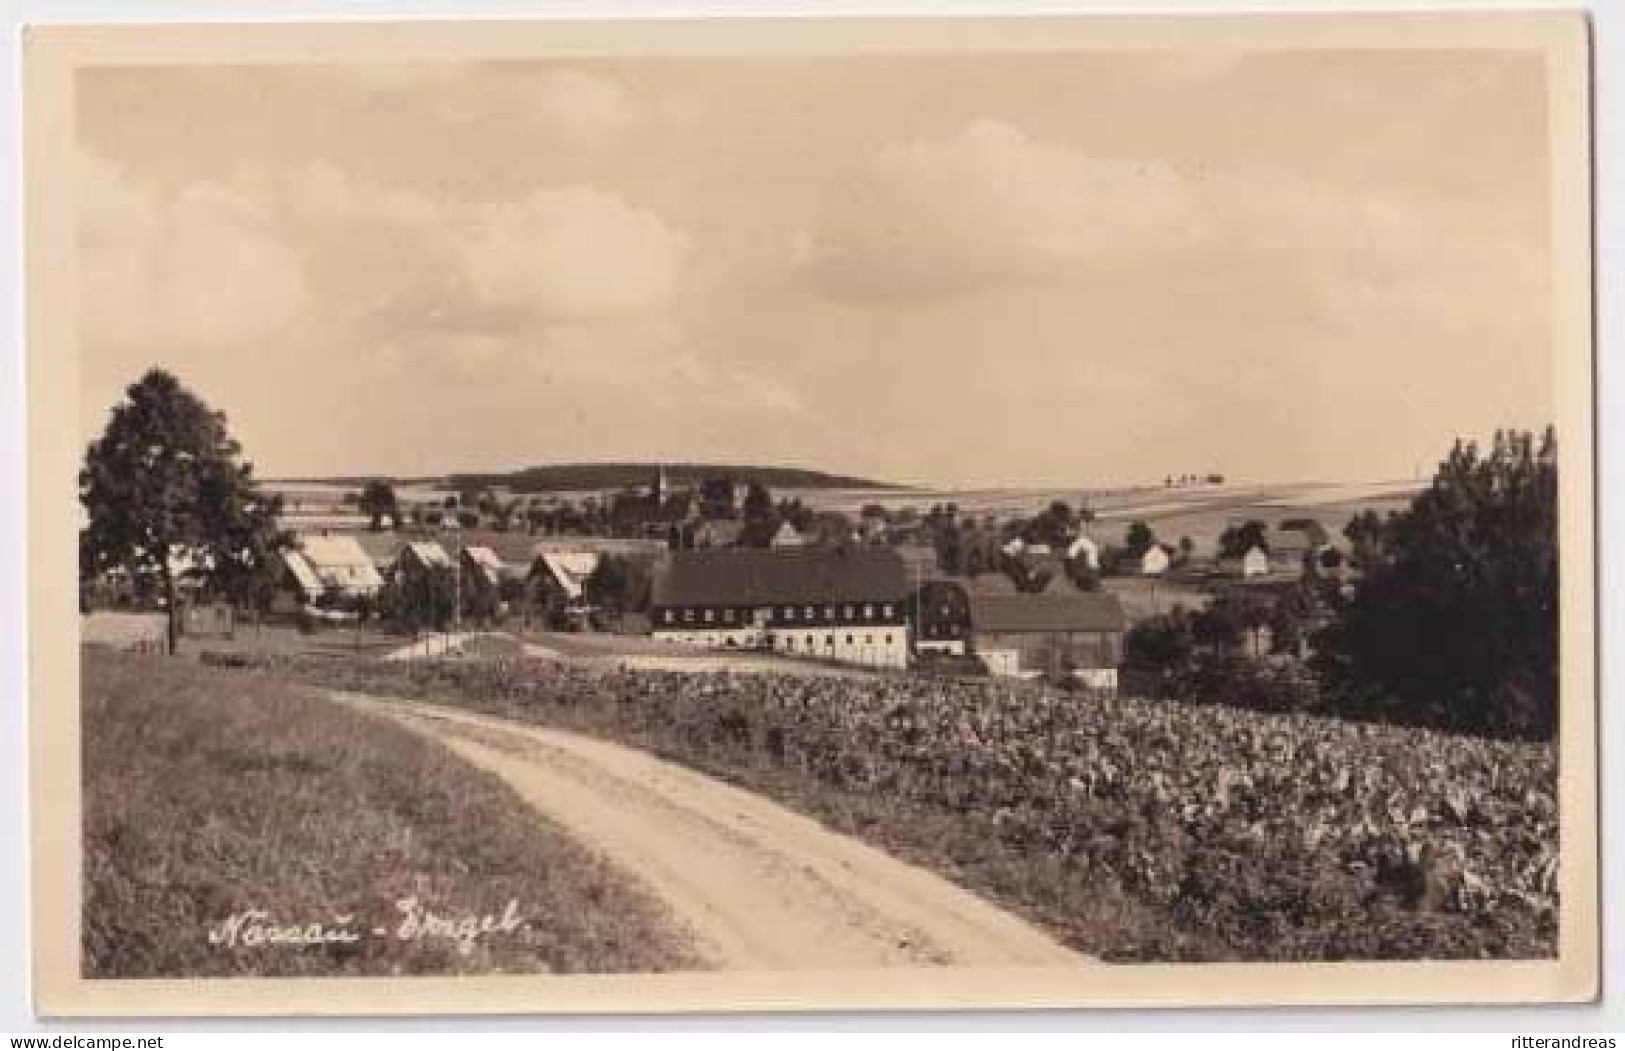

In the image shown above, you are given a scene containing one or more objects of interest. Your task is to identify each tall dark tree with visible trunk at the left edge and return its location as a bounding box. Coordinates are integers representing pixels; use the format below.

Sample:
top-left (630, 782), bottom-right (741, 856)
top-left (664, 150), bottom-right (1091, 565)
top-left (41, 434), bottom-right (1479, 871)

top-left (80, 369), bottom-right (289, 653)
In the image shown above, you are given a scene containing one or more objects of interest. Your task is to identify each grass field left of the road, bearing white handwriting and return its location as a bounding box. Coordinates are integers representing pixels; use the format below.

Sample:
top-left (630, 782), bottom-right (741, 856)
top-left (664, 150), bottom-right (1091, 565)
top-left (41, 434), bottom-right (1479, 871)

top-left (83, 648), bottom-right (692, 978)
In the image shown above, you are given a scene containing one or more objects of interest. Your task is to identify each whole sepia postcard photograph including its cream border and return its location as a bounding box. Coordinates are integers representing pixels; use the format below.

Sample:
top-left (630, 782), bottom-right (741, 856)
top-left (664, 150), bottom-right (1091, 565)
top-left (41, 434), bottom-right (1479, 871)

top-left (28, 15), bottom-right (1597, 1014)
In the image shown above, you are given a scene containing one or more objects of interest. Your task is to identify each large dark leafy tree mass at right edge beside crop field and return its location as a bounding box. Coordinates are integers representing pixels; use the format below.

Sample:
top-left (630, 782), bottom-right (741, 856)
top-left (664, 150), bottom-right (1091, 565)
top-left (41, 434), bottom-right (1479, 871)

top-left (1316, 429), bottom-right (1558, 737)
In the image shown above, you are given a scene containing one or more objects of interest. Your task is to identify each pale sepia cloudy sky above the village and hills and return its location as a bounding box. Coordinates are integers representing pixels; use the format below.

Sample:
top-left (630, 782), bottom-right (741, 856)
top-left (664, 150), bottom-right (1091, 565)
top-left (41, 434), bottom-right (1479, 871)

top-left (76, 50), bottom-right (1554, 487)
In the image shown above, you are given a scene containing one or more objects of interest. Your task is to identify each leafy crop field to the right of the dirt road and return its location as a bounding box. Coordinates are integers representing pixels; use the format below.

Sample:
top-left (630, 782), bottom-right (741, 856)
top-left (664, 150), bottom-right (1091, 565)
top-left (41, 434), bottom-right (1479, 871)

top-left (247, 661), bottom-right (1558, 962)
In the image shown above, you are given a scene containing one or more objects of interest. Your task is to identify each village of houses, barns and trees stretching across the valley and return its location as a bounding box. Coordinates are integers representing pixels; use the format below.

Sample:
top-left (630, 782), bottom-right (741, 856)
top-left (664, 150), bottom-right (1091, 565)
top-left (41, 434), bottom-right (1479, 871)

top-left (85, 466), bottom-right (1402, 694)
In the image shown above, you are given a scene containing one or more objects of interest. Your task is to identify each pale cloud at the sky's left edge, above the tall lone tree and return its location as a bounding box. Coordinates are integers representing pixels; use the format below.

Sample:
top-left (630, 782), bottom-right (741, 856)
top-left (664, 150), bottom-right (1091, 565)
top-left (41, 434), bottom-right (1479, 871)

top-left (76, 154), bottom-right (309, 349)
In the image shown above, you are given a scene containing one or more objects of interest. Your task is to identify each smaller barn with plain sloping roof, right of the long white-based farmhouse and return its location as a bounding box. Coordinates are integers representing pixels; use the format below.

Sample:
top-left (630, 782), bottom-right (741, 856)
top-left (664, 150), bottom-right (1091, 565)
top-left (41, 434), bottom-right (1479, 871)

top-left (969, 591), bottom-right (1128, 692)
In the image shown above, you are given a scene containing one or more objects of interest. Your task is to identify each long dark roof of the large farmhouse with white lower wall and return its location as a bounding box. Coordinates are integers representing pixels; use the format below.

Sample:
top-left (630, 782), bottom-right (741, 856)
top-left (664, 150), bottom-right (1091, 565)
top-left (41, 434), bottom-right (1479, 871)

top-left (653, 547), bottom-right (908, 606)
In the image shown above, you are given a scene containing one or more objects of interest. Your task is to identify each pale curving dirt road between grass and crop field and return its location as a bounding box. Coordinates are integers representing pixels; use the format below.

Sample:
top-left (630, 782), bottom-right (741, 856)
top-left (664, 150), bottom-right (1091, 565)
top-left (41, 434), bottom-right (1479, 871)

top-left (335, 694), bottom-right (1092, 970)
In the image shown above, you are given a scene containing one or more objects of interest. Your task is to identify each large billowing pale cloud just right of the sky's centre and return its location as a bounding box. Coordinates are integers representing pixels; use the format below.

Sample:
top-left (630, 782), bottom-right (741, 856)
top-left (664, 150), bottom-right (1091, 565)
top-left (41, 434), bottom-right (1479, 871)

top-left (793, 120), bottom-right (1198, 299)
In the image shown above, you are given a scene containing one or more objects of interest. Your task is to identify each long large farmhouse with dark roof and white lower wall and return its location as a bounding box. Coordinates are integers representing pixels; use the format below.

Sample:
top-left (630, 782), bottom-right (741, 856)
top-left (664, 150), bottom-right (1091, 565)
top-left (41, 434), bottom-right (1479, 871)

top-left (650, 546), bottom-right (908, 668)
